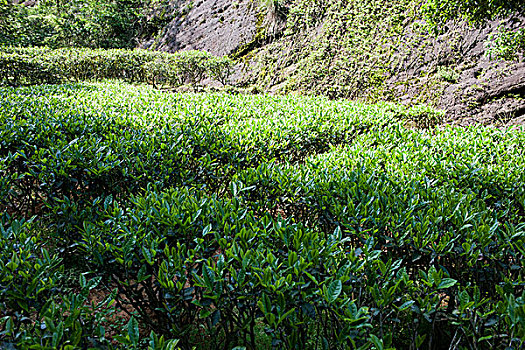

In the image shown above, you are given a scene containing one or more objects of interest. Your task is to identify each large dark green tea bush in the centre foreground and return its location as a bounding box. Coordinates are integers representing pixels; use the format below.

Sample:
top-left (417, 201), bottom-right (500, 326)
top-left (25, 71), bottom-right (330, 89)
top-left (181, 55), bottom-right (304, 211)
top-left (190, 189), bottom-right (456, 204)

top-left (82, 188), bottom-right (376, 348)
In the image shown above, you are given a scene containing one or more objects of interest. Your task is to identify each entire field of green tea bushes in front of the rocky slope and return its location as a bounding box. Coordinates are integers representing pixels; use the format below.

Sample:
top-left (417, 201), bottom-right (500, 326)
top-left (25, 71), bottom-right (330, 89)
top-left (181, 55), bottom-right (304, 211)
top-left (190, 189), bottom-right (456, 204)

top-left (0, 83), bottom-right (525, 349)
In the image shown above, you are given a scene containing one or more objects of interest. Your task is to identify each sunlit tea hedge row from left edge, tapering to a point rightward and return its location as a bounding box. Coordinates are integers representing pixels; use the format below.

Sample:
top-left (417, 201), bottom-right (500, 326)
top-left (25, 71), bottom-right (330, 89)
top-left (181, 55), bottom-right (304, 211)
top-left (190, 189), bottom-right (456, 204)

top-left (0, 85), bottom-right (392, 220)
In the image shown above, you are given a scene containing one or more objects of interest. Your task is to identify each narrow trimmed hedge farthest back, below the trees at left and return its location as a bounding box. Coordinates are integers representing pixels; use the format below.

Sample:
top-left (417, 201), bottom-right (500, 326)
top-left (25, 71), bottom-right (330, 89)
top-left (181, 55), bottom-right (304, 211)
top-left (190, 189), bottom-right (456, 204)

top-left (0, 47), bottom-right (233, 87)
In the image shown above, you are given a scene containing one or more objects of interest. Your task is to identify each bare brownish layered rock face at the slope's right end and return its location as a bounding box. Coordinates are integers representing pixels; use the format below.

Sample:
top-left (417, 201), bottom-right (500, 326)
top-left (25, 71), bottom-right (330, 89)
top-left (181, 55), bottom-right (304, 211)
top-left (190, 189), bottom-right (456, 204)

top-left (382, 18), bottom-right (525, 125)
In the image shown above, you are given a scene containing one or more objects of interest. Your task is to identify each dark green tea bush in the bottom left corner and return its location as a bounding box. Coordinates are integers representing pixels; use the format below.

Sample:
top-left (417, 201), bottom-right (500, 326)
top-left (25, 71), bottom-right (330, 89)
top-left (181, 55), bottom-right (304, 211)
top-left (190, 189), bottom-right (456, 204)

top-left (0, 217), bottom-right (111, 349)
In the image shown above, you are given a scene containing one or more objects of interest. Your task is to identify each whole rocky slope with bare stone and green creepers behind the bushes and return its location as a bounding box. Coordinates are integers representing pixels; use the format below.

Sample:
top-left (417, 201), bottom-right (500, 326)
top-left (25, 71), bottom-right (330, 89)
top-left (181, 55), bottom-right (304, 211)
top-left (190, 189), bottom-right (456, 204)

top-left (144, 0), bottom-right (525, 125)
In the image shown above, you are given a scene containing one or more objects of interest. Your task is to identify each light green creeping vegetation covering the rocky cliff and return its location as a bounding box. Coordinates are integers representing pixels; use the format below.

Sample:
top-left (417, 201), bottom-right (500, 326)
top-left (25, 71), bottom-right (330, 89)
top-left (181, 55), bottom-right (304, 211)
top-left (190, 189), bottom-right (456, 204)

top-left (248, 0), bottom-right (524, 103)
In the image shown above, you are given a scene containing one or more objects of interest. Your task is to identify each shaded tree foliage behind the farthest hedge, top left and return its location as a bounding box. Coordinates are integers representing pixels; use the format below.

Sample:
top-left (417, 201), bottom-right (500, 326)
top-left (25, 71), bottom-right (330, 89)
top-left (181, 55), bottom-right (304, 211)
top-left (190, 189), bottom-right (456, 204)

top-left (0, 0), bottom-right (170, 48)
